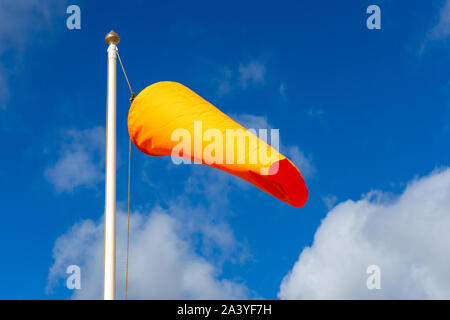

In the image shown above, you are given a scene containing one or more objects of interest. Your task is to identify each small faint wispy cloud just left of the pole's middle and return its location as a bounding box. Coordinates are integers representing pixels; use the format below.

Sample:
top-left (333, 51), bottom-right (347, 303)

top-left (45, 127), bottom-right (105, 192)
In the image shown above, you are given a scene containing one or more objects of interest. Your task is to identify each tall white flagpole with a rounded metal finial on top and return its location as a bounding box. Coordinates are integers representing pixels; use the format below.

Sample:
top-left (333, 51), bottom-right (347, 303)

top-left (103, 31), bottom-right (120, 300)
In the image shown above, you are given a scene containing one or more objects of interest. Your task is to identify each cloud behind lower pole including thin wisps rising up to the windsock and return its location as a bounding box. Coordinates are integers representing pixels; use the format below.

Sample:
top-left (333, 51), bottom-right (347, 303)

top-left (47, 156), bottom-right (254, 299)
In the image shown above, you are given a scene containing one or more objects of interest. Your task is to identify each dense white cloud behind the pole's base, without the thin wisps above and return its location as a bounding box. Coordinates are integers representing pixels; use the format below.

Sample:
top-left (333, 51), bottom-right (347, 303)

top-left (47, 208), bottom-right (249, 299)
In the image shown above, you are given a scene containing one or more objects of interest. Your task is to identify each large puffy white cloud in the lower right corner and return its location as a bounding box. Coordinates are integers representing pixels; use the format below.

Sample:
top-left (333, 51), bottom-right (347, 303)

top-left (278, 169), bottom-right (450, 299)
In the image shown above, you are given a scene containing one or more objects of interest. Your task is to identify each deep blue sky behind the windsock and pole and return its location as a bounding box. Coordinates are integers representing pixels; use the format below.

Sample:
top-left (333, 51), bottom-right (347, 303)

top-left (0, 0), bottom-right (450, 299)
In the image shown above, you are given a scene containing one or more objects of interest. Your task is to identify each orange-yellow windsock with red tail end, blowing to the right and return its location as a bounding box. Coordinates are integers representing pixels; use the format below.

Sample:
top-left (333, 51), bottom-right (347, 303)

top-left (128, 81), bottom-right (308, 207)
